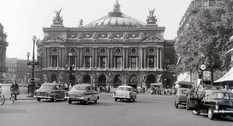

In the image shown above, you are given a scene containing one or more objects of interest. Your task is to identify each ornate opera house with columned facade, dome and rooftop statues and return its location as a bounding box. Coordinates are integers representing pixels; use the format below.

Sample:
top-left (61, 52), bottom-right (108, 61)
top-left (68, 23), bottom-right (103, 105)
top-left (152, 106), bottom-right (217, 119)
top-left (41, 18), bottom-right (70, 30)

top-left (36, 1), bottom-right (176, 88)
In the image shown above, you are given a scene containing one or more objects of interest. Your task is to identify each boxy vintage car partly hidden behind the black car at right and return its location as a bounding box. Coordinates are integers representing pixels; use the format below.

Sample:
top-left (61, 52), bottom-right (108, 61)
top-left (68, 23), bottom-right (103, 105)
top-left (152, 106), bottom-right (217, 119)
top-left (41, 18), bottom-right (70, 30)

top-left (174, 81), bottom-right (193, 108)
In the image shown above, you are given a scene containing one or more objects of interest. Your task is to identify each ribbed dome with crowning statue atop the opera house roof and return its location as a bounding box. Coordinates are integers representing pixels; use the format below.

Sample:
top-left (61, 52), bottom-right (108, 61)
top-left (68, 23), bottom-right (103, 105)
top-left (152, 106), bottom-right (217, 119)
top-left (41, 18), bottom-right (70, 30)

top-left (86, 1), bottom-right (145, 27)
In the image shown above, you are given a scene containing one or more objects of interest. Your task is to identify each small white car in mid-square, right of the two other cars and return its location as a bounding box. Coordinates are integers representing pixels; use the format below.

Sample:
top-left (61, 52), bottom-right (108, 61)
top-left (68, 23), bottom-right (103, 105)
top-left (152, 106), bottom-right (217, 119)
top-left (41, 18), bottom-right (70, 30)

top-left (113, 86), bottom-right (137, 101)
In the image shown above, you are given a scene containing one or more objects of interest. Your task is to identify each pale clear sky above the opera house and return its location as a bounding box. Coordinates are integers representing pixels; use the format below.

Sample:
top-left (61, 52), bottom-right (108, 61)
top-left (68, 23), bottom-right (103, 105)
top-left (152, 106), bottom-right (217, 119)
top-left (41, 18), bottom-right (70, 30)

top-left (0, 0), bottom-right (192, 59)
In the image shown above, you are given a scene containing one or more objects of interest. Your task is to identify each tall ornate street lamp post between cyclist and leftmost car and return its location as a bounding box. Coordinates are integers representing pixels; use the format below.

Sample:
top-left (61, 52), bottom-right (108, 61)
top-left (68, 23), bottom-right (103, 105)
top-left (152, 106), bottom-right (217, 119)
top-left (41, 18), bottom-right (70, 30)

top-left (27, 36), bottom-right (39, 97)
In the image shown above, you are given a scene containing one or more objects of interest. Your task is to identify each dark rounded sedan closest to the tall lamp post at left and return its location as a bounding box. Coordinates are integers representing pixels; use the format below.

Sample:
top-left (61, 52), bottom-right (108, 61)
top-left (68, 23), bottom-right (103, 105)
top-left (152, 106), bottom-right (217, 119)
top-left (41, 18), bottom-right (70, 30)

top-left (34, 83), bottom-right (67, 102)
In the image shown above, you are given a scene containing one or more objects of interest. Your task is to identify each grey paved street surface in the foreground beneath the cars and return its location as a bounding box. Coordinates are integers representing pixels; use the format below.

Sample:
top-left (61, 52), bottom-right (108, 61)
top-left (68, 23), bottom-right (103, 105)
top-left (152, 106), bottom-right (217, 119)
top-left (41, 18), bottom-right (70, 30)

top-left (0, 93), bottom-right (233, 126)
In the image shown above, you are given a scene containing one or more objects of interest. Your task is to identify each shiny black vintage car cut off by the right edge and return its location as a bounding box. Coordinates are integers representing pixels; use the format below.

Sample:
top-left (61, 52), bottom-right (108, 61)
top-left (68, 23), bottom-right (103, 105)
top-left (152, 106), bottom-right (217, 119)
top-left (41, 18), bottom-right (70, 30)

top-left (189, 89), bottom-right (233, 120)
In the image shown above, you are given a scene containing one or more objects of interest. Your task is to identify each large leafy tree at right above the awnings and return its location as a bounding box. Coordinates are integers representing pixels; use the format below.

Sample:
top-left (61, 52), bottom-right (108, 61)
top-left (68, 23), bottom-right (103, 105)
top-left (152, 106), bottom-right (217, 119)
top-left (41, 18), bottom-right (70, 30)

top-left (173, 0), bottom-right (233, 83)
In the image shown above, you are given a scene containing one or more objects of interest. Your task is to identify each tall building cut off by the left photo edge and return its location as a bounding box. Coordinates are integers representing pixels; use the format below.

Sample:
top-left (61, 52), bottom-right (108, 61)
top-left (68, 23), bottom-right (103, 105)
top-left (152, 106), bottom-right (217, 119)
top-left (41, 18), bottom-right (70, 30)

top-left (0, 23), bottom-right (8, 83)
